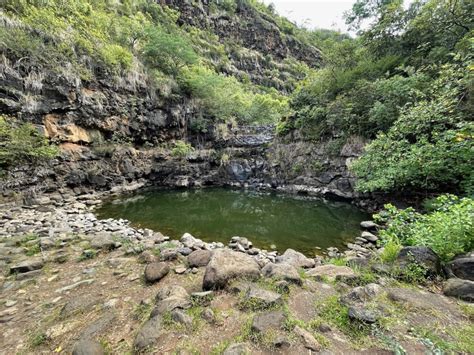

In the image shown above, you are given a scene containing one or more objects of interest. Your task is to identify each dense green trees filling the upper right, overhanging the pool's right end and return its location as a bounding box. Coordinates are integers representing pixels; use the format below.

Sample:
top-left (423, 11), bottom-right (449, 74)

top-left (286, 0), bottom-right (474, 193)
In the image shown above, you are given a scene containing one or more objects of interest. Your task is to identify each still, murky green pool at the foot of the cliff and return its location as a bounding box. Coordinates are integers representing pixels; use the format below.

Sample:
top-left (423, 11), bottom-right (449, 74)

top-left (96, 188), bottom-right (368, 255)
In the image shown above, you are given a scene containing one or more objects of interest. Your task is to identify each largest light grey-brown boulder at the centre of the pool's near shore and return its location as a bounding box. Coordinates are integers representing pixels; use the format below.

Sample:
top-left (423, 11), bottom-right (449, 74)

top-left (203, 249), bottom-right (260, 290)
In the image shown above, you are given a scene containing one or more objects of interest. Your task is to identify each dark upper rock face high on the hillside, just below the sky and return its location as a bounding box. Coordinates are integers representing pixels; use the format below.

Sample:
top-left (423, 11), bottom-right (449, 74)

top-left (166, 0), bottom-right (322, 92)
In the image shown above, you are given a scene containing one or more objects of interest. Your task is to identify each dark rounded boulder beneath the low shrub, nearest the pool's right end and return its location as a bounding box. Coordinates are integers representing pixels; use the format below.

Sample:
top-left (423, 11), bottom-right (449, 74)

top-left (397, 246), bottom-right (441, 276)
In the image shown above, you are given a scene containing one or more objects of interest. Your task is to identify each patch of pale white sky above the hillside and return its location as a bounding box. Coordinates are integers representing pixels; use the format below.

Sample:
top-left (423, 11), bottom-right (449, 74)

top-left (263, 0), bottom-right (356, 32)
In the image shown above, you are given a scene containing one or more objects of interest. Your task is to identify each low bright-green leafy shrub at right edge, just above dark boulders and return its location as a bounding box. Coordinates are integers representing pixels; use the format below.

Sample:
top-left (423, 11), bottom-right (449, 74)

top-left (374, 195), bottom-right (474, 261)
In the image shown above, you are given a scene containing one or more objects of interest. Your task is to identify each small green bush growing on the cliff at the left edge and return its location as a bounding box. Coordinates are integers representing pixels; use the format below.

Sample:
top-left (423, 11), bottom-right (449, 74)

top-left (0, 115), bottom-right (58, 168)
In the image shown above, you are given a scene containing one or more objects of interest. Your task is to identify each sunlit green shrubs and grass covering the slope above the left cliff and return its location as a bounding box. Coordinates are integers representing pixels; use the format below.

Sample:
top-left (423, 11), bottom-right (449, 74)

top-left (0, 0), bottom-right (298, 131)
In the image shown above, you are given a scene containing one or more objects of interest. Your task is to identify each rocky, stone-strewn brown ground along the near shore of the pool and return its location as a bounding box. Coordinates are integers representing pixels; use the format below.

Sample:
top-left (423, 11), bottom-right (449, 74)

top-left (0, 183), bottom-right (474, 355)
